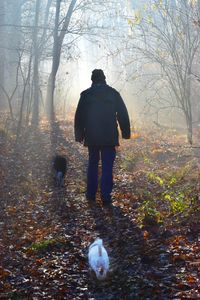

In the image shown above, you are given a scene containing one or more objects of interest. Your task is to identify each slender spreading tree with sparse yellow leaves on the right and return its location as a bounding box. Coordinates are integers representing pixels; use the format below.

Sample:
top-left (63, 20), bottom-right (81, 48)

top-left (128, 0), bottom-right (200, 143)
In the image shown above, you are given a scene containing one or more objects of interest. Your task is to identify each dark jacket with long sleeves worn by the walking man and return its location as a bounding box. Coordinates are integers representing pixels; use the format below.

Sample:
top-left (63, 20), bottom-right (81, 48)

top-left (75, 84), bottom-right (130, 146)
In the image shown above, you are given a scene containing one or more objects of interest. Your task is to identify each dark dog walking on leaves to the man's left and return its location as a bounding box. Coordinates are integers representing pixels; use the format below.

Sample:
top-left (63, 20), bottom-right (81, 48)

top-left (53, 155), bottom-right (67, 187)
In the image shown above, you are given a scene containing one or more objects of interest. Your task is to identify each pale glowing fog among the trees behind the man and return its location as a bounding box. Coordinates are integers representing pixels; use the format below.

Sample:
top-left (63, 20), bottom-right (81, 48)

top-left (0, 0), bottom-right (200, 140)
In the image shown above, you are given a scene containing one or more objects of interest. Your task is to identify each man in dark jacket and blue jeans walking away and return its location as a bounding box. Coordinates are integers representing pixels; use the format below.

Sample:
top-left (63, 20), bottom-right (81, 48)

top-left (75, 69), bottom-right (130, 205)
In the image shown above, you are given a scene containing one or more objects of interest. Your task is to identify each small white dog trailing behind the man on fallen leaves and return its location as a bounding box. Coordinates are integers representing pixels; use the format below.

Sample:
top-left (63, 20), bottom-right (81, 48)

top-left (88, 238), bottom-right (109, 280)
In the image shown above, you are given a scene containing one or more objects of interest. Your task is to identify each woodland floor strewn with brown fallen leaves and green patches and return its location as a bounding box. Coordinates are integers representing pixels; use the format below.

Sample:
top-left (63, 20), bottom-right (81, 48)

top-left (0, 118), bottom-right (200, 300)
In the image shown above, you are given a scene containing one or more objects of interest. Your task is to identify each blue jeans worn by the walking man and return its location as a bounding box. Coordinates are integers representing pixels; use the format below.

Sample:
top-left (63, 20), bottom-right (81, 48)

top-left (87, 147), bottom-right (116, 202)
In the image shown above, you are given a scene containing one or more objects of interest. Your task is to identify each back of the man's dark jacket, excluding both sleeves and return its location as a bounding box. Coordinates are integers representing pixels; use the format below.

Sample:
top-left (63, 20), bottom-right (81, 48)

top-left (83, 84), bottom-right (118, 146)
